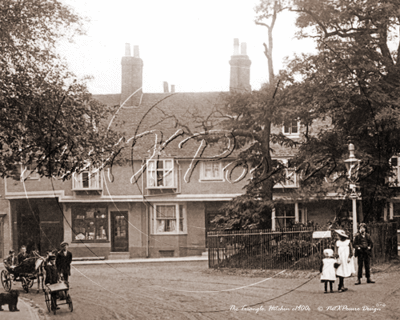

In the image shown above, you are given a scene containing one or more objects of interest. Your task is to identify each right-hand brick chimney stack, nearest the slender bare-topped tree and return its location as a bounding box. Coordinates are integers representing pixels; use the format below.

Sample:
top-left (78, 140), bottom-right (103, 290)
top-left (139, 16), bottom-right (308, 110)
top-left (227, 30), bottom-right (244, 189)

top-left (229, 38), bottom-right (251, 91)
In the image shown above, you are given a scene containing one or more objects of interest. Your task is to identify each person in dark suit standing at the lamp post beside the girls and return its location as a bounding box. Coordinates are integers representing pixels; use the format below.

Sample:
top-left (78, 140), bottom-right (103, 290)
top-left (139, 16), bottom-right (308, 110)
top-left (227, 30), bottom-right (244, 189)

top-left (353, 224), bottom-right (375, 285)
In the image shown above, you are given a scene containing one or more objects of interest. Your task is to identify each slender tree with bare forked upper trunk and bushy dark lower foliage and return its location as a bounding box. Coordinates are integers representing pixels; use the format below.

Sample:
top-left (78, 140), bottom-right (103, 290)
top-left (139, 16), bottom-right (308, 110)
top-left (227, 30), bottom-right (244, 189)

top-left (215, 0), bottom-right (295, 229)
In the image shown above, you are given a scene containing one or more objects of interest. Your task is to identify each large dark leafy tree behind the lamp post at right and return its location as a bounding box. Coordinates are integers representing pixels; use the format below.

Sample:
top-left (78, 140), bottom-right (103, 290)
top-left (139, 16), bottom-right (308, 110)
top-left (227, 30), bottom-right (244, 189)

top-left (282, 0), bottom-right (400, 220)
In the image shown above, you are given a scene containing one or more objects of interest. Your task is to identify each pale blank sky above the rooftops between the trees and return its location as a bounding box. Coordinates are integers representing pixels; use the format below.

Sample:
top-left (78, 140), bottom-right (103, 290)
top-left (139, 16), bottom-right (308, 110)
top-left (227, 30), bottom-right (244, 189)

top-left (59, 0), bottom-right (314, 94)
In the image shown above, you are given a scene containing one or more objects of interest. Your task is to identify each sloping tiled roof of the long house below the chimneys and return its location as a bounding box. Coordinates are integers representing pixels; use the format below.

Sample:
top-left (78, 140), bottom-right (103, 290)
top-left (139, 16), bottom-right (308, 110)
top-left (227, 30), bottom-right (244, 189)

top-left (94, 92), bottom-right (233, 159)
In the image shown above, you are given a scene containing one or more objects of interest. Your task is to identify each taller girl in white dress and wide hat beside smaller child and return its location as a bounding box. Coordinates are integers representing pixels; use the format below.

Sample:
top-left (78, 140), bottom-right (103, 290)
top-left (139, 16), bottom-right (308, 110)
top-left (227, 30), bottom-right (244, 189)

top-left (335, 230), bottom-right (353, 292)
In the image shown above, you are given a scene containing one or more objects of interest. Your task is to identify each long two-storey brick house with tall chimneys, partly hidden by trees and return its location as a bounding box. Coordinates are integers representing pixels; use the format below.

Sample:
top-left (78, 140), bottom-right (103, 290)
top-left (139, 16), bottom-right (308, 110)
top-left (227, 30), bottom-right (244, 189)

top-left (0, 39), bottom-right (400, 259)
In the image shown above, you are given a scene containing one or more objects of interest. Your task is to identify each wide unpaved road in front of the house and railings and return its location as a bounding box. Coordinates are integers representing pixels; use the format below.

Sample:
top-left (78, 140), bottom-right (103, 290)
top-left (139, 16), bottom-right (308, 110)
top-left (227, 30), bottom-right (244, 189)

top-left (10, 261), bottom-right (400, 320)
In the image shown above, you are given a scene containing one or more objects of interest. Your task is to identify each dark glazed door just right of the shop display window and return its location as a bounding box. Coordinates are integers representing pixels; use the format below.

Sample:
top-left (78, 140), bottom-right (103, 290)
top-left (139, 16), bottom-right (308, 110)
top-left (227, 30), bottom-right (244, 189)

top-left (111, 211), bottom-right (129, 252)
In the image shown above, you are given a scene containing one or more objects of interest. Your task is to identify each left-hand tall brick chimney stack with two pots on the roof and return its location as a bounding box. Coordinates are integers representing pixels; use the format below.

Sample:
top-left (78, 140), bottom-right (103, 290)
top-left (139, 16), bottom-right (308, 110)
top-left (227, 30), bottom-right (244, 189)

top-left (120, 43), bottom-right (143, 106)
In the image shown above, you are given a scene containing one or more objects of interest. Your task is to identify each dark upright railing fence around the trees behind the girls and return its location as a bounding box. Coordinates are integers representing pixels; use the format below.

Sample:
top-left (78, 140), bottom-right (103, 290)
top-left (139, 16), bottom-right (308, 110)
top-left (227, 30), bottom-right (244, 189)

top-left (207, 223), bottom-right (397, 269)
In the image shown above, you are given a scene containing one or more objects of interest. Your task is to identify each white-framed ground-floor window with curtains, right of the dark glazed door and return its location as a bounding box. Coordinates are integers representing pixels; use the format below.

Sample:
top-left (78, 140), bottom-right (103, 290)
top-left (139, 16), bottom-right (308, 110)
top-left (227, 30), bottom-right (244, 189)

top-left (150, 203), bottom-right (187, 235)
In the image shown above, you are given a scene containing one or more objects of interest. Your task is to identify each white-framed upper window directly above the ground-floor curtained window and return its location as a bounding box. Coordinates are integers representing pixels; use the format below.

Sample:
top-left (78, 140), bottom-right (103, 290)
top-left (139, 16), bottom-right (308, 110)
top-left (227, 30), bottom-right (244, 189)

top-left (147, 159), bottom-right (175, 189)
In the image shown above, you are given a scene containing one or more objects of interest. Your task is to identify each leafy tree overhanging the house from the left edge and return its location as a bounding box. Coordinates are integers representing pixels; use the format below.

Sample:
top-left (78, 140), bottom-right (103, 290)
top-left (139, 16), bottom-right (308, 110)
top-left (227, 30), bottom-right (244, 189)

top-left (0, 0), bottom-right (120, 179)
